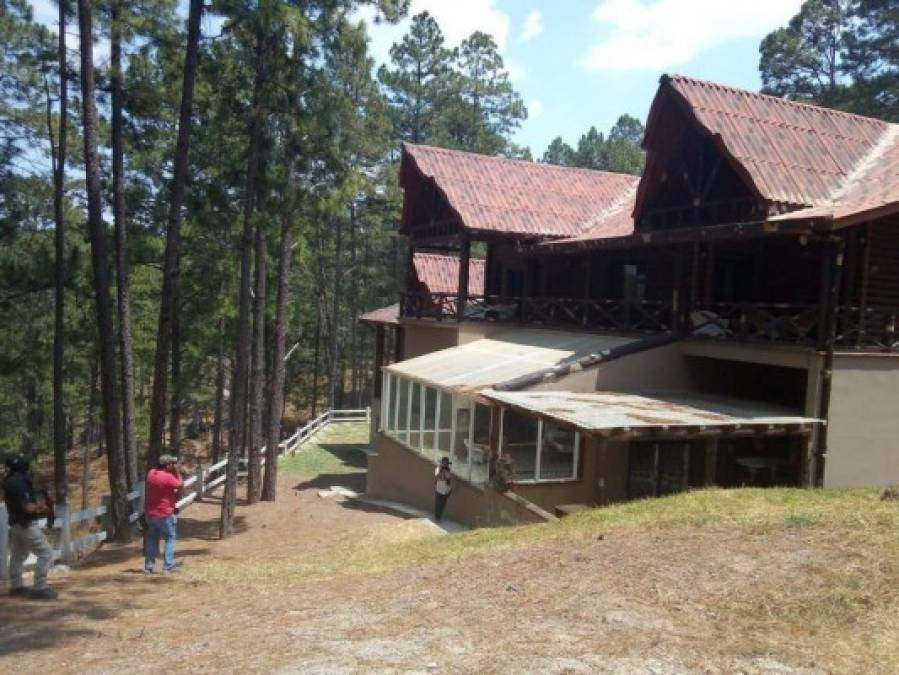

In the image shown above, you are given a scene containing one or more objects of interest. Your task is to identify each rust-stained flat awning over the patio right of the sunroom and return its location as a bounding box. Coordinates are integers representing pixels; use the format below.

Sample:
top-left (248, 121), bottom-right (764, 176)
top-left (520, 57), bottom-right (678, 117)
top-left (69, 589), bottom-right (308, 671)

top-left (483, 391), bottom-right (821, 436)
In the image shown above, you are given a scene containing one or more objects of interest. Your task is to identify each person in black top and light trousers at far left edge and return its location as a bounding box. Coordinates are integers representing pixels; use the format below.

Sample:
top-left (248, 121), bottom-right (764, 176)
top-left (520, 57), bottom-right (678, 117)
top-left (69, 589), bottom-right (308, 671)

top-left (3, 455), bottom-right (57, 600)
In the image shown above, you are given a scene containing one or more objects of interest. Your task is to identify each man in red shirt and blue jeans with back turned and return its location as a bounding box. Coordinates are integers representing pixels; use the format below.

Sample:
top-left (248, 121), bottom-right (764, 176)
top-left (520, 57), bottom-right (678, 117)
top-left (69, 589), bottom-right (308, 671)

top-left (144, 455), bottom-right (184, 574)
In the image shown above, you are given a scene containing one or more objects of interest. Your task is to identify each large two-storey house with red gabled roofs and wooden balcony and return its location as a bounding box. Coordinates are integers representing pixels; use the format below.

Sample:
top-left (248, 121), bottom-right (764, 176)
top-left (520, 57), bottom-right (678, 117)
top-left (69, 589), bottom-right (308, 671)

top-left (358, 76), bottom-right (899, 524)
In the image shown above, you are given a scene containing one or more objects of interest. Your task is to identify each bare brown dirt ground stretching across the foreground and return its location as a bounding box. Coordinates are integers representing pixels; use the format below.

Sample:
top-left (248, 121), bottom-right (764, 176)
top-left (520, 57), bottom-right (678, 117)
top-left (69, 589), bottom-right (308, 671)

top-left (0, 430), bottom-right (899, 675)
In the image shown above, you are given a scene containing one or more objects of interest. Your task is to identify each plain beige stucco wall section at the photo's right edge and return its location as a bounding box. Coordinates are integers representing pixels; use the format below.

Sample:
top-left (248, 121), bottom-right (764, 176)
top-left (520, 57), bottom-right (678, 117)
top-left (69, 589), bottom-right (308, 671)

top-left (824, 355), bottom-right (899, 487)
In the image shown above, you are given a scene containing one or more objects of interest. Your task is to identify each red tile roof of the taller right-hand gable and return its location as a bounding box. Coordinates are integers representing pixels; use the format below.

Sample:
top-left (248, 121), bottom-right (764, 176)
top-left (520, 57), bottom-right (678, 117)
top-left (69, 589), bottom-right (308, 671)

top-left (647, 75), bottom-right (895, 211)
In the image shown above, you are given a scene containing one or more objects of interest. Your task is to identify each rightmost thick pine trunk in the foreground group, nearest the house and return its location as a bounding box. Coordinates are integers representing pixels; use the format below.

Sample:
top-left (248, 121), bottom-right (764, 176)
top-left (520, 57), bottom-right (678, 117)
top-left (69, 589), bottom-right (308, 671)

top-left (262, 197), bottom-right (293, 502)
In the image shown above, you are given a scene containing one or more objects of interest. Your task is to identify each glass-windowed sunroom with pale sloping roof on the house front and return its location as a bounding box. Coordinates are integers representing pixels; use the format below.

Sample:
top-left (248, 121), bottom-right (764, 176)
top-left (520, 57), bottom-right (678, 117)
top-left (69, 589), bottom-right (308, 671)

top-left (380, 329), bottom-right (633, 484)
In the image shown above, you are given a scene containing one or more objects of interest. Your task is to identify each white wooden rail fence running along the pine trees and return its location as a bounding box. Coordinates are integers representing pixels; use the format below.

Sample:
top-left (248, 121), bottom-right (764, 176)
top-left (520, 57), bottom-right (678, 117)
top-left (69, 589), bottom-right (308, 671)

top-left (0, 408), bottom-right (371, 579)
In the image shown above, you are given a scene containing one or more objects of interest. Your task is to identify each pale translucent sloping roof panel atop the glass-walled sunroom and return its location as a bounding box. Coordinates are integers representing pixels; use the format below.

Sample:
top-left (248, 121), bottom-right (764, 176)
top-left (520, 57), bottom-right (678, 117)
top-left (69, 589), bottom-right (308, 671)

top-left (386, 328), bottom-right (640, 393)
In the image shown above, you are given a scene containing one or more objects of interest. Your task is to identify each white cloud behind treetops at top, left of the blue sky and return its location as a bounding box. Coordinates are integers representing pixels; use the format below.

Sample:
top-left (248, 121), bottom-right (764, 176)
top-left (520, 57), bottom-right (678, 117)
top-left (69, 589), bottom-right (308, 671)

top-left (356, 0), bottom-right (510, 63)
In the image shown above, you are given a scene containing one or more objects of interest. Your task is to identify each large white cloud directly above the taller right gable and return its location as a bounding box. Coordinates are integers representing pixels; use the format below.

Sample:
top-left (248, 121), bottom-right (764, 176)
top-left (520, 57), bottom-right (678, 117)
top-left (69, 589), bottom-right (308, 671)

top-left (581, 0), bottom-right (802, 71)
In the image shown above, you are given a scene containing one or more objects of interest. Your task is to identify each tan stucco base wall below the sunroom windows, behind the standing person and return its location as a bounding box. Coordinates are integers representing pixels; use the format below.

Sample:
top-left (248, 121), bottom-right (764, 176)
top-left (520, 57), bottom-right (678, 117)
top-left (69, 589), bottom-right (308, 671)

top-left (365, 434), bottom-right (544, 527)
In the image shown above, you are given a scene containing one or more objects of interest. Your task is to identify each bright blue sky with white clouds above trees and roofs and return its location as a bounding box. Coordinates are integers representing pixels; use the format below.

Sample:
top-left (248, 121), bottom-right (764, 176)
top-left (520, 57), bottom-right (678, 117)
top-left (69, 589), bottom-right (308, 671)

top-left (32, 0), bottom-right (802, 158)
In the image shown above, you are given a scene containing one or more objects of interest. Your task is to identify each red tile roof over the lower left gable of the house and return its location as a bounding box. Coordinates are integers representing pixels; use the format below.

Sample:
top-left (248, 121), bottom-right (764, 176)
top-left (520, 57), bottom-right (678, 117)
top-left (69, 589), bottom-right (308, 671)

top-left (400, 143), bottom-right (639, 237)
